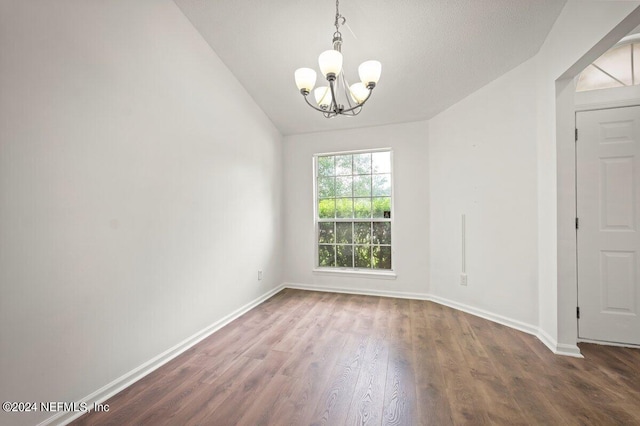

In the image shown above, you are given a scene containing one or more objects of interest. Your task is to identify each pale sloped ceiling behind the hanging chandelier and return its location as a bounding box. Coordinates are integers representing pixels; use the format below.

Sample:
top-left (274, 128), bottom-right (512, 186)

top-left (174, 0), bottom-right (566, 135)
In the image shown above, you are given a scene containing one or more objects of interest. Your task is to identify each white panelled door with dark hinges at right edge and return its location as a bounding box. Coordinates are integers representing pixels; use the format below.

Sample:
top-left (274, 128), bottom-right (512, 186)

top-left (576, 107), bottom-right (640, 345)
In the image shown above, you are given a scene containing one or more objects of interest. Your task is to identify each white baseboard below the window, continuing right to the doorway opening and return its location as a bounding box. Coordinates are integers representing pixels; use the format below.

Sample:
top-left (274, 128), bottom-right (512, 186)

top-left (283, 283), bottom-right (584, 358)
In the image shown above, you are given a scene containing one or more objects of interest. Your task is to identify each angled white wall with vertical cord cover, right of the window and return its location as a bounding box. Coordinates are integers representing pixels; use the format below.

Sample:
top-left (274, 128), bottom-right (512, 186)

top-left (429, 60), bottom-right (538, 326)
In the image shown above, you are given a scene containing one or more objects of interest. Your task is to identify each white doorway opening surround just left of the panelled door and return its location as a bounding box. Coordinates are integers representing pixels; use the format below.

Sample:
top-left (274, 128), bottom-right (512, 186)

top-left (552, 5), bottom-right (640, 358)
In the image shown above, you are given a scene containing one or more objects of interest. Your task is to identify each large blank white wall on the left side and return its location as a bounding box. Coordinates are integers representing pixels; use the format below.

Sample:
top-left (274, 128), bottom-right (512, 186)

top-left (0, 0), bottom-right (282, 424)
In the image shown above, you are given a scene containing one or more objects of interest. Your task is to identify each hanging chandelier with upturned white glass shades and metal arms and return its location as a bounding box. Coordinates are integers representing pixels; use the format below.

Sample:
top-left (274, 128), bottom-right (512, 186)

top-left (295, 0), bottom-right (382, 118)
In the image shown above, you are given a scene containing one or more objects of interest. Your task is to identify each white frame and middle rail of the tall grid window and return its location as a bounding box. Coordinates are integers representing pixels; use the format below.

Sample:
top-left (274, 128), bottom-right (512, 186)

top-left (313, 147), bottom-right (396, 279)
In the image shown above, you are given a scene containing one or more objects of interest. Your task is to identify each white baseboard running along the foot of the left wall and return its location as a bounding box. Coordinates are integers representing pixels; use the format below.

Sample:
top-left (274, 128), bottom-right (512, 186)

top-left (38, 285), bottom-right (284, 426)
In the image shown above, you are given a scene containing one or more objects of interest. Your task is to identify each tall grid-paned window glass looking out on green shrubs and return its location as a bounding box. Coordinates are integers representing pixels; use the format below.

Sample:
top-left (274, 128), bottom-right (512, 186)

top-left (314, 149), bottom-right (393, 271)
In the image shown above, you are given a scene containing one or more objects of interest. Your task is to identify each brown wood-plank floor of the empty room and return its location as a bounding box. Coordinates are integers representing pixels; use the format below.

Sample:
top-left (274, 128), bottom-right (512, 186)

top-left (73, 289), bottom-right (640, 425)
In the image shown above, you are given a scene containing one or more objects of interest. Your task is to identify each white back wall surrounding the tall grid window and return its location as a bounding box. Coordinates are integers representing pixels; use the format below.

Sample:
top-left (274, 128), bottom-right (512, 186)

top-left (284, 121), bottom-right (429, 296)
